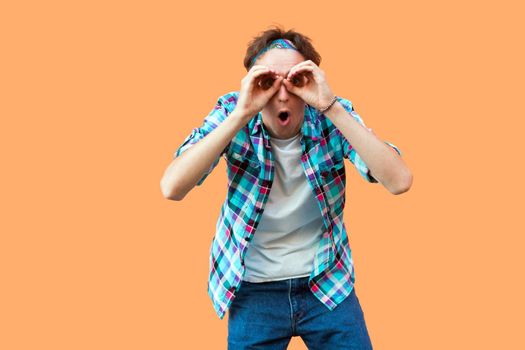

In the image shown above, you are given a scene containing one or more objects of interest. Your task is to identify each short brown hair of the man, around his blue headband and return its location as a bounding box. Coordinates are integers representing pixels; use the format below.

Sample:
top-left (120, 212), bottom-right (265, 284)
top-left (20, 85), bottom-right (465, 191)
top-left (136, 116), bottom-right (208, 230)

top-left (244, 25), bottom-right (321, 71)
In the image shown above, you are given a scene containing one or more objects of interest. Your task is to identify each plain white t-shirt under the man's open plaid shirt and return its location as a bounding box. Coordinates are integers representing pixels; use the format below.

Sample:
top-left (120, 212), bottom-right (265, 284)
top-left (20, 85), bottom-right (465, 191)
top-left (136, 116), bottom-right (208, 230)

top-left (243, 133), bottom-right (323, 282)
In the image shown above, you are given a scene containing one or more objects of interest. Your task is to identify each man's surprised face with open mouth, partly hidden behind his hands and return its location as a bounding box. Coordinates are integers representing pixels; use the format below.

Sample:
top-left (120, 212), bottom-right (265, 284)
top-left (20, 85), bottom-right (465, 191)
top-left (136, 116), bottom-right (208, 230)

top-left (255, 49), bottom-right (305, 139)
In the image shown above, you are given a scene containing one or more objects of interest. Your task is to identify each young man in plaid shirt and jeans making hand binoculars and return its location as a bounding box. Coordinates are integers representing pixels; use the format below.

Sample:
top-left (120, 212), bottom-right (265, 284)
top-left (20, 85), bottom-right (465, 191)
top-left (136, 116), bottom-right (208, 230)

top-left (161, 28), bottom-right (412, 349)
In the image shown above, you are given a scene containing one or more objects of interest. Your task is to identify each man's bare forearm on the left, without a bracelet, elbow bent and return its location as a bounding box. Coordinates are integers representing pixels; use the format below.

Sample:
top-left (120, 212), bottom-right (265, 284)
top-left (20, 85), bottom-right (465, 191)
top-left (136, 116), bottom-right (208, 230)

top-left (160, 110), bottom-right (249, 200)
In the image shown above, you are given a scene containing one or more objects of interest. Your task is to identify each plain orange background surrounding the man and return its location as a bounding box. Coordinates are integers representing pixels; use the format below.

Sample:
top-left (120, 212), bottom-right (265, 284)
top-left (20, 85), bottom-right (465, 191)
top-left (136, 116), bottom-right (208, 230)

top-left (0, 1), bottom-right (525, 350)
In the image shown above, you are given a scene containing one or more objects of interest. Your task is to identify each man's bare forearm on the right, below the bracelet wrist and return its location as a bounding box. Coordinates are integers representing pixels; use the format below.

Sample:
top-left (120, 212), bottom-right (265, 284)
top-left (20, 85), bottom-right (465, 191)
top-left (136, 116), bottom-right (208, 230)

top-left (324, 102), bottom-right (412, 194)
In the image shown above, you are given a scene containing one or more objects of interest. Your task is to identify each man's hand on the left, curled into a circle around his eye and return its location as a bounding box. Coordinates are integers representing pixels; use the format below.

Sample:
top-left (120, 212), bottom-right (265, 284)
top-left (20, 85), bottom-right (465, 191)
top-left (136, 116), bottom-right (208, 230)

top-left (235, 65), bottom-right (283, 121)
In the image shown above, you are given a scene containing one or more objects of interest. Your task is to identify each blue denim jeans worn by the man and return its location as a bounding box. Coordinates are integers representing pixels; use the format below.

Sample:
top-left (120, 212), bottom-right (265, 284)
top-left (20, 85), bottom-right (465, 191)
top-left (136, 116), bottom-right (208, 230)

top-left (228, 277), bottom-right (372, 350)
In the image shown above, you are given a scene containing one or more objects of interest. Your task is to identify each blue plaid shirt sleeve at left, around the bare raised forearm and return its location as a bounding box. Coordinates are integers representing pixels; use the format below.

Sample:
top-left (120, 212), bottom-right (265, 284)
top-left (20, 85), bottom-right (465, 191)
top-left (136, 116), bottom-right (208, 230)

top-left (173, 96), bottom-right (230, 186)
